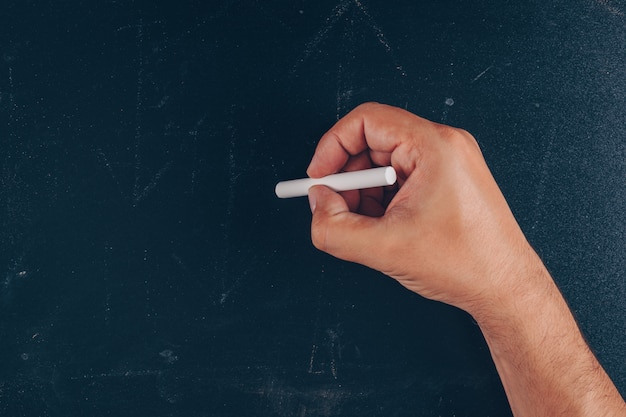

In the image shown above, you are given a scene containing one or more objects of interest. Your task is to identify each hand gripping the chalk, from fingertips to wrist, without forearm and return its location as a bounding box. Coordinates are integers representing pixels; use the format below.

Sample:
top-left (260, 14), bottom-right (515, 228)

top-left (307, 103), bottom-right (541, 314)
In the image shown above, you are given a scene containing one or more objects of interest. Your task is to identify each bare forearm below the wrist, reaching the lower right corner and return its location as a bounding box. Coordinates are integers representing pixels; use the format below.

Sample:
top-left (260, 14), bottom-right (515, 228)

top-left (477, 252), bottom-right (626, 417)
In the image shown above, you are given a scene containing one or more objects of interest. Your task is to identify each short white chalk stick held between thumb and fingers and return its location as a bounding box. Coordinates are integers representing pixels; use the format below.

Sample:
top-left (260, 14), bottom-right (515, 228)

top-left (275, 167), bottom-right (396, 198)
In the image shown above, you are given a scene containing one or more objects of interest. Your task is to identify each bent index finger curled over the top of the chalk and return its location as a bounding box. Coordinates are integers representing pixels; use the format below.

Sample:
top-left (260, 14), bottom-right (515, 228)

top-left (307, 103), bottom-right (431, 178)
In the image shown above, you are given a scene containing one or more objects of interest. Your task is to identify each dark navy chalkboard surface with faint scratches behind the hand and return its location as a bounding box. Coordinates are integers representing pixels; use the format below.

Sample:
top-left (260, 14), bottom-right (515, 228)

top-left (0, 0), bottom-right (626, 417)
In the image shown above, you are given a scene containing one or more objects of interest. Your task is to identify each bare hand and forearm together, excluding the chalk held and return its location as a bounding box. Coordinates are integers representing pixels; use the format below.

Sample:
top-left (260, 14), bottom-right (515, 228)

top-left (307, 103), bottom-right (626, 417)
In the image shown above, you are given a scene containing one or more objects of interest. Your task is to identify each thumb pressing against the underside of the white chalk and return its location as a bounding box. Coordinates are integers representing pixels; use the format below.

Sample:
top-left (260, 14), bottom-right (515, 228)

top-left (309, 186), bottom-right (383, 266)
